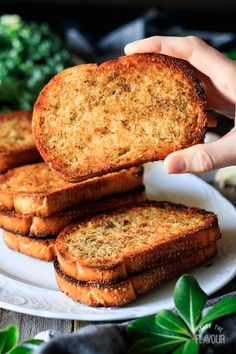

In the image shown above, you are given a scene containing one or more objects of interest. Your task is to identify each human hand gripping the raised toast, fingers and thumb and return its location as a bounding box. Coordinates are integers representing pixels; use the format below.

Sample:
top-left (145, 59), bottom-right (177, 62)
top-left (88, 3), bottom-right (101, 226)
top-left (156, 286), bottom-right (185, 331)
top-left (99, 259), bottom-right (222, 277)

top-left (125, 36), bottom-right (236, 173)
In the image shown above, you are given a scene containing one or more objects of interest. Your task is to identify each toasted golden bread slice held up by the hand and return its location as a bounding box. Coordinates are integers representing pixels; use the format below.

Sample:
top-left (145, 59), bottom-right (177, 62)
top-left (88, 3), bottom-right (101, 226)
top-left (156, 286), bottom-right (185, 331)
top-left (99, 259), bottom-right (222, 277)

top-left (33, 54), bottom-right (206, 182)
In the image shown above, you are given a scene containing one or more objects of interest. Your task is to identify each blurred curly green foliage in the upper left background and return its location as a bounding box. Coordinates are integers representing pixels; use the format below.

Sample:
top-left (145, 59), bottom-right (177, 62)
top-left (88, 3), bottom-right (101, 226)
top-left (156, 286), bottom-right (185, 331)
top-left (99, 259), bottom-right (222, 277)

top-left (0, 15), bottom-right (71, 111)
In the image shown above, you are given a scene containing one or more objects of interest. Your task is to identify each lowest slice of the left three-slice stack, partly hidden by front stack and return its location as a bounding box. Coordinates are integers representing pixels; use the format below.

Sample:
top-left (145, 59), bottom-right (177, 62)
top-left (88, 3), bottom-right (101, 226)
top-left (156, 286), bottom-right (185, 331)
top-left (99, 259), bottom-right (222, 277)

top-left (3, 231), bottom-right (55, 262)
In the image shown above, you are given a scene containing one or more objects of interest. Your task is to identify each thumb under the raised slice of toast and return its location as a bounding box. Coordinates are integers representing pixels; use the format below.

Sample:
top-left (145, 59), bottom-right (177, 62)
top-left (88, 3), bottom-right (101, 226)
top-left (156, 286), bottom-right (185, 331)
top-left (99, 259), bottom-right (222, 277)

top-left (164, 128), bottom-right (236, 173)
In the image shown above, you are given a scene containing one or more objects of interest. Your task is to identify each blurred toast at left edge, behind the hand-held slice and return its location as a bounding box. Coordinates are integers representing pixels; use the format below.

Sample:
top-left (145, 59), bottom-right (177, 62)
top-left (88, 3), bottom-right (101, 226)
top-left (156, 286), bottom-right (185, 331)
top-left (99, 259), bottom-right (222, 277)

top-left (0, 110), bottom-right (42, 172)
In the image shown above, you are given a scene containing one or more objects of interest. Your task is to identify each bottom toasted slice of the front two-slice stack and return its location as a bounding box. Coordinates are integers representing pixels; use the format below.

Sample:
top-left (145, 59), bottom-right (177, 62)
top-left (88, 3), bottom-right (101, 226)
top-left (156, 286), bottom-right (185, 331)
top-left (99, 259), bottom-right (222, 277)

top-left (54, 244), bottom-right (217, 307)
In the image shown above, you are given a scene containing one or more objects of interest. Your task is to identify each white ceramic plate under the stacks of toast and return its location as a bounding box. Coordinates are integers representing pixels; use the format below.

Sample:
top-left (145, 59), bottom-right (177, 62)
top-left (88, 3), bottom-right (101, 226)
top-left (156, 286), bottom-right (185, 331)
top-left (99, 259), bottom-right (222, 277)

top-left (0, 163), bottom-right (236, 321)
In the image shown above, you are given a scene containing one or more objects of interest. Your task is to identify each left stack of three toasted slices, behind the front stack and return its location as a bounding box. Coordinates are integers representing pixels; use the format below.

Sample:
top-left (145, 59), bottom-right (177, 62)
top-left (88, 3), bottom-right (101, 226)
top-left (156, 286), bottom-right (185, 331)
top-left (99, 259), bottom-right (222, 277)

top-left (0, 162), bottom-right (144, 261)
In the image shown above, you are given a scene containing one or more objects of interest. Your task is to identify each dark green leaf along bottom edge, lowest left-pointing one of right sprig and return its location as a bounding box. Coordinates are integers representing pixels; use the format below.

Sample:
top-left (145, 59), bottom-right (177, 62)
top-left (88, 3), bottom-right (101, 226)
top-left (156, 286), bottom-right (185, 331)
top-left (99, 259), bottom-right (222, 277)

top-left (128, 336), bottom-right (186, 354)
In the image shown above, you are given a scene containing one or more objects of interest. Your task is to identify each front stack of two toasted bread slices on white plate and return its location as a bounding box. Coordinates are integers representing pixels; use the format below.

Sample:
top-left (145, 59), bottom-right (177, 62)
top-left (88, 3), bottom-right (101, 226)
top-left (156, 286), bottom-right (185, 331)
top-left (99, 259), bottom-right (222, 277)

top-left (54, 201), bottom-right (220, 307)
